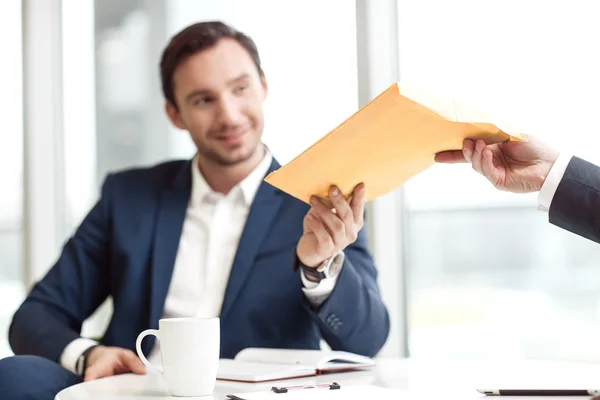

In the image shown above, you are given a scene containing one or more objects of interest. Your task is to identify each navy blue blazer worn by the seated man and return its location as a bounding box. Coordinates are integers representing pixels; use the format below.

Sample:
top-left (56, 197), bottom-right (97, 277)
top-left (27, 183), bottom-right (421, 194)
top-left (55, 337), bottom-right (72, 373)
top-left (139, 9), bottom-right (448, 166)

top-left (9, 160), bottom-right (389, 361)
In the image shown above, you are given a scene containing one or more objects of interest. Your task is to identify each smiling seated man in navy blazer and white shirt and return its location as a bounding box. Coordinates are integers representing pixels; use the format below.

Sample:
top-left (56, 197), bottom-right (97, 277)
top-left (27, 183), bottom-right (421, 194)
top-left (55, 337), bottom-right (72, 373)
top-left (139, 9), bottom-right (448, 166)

top-left (0, 22), bottom-right (389, 399)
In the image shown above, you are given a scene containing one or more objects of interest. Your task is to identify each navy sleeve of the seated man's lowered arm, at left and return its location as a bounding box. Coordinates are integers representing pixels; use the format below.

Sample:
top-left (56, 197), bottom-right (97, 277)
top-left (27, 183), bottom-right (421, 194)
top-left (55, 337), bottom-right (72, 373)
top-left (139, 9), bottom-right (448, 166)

top-left (9, 177), bottom-right (110, 362)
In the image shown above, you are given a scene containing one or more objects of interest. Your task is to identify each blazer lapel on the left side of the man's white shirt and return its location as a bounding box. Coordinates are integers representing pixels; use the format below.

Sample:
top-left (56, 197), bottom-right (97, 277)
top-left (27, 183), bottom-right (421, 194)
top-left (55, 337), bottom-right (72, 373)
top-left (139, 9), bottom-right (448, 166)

top-left (144, 162), bottom-right (192, 332)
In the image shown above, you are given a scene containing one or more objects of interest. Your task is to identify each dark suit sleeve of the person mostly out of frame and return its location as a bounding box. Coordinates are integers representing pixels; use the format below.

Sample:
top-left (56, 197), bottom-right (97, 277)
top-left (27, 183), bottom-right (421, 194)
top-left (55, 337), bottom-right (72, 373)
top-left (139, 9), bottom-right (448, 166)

top-left (549, 157), bottom-right (600, 243)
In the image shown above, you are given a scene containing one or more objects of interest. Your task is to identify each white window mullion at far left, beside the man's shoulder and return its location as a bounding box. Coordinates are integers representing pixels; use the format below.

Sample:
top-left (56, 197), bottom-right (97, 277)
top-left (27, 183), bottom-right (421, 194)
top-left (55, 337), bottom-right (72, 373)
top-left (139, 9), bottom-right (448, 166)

top-left (23, 0), bottom-right (65, 286)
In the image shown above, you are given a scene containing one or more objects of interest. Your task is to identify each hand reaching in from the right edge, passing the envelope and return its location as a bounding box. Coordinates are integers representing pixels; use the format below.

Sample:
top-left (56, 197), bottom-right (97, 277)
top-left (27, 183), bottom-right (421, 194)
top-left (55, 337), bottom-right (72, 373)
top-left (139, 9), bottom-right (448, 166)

top-left (435, 139), bottom-right (558, 193)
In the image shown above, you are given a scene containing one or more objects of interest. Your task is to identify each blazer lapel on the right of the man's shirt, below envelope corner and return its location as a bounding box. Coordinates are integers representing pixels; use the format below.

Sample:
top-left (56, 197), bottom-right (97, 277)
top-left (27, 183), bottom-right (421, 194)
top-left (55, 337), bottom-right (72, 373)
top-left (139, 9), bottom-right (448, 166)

top-left (221, 159), bottom-right (283, 319)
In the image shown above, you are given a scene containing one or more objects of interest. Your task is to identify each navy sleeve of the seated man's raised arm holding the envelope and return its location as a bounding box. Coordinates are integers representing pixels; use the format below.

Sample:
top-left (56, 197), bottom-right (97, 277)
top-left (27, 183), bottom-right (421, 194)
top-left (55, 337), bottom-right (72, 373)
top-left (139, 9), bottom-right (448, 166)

top-left (305, 223), bottom-right (390, 357)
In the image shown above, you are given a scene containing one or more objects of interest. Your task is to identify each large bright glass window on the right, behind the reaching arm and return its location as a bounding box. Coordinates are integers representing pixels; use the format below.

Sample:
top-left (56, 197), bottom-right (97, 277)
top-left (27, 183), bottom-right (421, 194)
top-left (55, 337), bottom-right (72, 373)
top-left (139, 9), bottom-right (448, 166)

top-left (398, 0), bottom-right (600, 360)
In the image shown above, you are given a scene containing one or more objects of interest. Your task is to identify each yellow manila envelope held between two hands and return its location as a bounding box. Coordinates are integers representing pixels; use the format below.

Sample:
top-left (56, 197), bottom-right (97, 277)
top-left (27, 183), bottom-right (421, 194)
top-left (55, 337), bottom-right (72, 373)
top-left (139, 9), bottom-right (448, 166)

top-left (265, 83), bottom-right (526, 203)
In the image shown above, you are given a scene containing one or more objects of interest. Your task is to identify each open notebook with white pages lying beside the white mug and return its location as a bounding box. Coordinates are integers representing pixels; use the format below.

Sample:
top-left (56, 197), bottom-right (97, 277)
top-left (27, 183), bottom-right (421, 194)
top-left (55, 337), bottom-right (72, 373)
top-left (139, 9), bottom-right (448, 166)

top-left (217, 348), bottom-right (375, 382)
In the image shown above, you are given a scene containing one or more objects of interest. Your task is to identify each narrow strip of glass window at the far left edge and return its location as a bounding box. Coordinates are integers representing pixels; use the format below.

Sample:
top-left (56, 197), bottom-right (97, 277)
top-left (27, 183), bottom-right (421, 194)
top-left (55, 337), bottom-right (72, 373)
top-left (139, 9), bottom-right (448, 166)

top-left (0, 0), bottom-right (25, 358)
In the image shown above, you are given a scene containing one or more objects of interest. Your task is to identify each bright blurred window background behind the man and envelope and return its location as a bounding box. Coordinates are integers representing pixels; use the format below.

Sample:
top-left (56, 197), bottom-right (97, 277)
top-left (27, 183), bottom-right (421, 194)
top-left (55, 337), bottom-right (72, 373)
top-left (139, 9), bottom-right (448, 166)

top-left (0, 0), bottom-right (600, 361)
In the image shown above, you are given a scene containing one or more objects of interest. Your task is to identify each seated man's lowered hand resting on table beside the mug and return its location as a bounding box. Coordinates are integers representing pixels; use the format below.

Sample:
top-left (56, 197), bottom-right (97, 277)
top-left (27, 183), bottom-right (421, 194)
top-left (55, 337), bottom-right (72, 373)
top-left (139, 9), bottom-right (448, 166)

top-left (83, 346), bottom-right (146, 382)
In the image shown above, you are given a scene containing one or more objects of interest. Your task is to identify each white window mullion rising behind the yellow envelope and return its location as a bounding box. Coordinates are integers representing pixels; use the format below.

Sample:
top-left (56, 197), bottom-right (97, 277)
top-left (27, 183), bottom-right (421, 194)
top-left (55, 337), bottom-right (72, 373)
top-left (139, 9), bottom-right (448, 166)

top-left (356, 0), bottom-right (407, 357)
